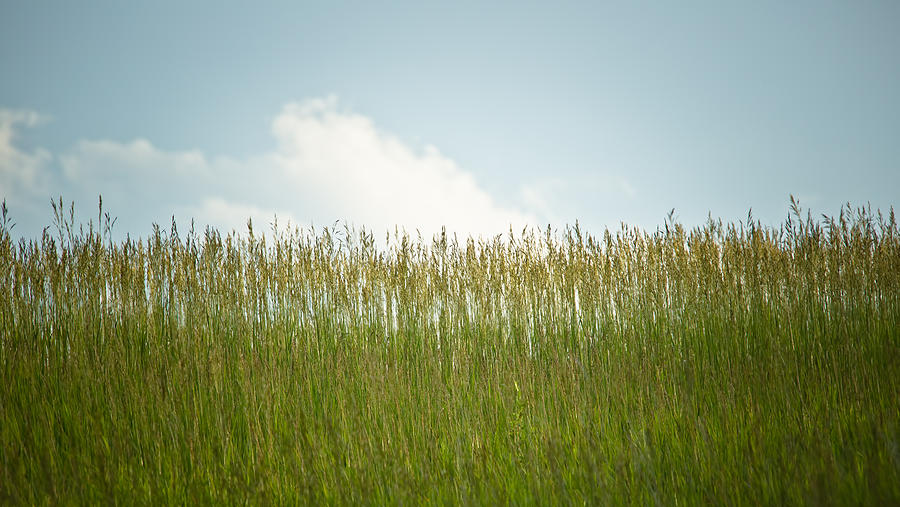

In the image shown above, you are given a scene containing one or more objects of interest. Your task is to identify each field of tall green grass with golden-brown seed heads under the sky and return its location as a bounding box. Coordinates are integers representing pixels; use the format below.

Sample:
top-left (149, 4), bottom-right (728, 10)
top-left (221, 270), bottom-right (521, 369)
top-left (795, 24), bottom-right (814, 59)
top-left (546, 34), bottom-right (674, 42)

top-left (0, 202), bottom-right (900, 504)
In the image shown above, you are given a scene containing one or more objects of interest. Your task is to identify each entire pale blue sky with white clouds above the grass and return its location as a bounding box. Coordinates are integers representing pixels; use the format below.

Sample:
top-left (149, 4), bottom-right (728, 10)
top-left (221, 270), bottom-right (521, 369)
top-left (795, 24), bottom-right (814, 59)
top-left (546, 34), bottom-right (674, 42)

top-left (0, 0), bottom-right (900, 237)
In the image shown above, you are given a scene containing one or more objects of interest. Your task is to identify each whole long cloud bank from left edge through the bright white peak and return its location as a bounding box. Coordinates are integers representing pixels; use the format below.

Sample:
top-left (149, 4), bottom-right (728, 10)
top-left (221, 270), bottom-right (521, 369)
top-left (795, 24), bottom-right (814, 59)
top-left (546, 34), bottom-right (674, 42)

top-left (0, 97), bottom-right (537, 237)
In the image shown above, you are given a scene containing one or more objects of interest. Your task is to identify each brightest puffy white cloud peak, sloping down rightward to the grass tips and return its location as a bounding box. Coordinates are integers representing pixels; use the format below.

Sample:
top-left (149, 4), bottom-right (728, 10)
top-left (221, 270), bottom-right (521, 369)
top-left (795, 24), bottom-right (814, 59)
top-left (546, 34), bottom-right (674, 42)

top-left (272, 98), bottom-right (534, 234)
